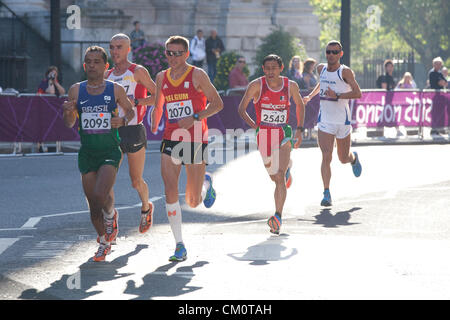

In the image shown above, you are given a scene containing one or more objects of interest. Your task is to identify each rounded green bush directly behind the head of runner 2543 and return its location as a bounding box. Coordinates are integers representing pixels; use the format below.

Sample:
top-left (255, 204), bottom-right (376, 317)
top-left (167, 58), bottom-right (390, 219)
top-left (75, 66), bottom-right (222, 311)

top-left (251, 27), bottom-right (307, 79)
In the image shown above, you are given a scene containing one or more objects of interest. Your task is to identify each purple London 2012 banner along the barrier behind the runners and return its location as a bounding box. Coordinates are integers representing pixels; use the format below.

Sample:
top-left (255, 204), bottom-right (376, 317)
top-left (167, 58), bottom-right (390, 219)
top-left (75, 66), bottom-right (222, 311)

top-left (0, 90), bottom-right (450, 142)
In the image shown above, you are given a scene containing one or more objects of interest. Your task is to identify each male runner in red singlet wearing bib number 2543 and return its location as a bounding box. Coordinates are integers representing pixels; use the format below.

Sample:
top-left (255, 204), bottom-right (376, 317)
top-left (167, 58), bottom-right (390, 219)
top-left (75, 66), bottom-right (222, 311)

top-left (239, 54), bottom-right (305, 234)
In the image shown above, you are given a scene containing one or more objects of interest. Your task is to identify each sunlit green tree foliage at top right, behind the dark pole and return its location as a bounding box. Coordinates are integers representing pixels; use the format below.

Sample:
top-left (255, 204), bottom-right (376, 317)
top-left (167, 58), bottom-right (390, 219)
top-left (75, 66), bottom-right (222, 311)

top-left (310, 0), bottom-right (450, 69)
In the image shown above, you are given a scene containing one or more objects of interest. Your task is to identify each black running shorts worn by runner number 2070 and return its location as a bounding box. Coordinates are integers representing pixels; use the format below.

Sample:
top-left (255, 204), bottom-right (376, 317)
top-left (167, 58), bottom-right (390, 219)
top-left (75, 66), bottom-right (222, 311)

top-left (160, 140), bottom-right (208, 164)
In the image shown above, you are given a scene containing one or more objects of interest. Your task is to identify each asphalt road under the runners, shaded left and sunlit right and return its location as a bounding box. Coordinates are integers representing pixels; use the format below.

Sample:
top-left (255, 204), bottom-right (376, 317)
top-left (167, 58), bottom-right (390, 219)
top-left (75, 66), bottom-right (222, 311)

top-left (0, 144), bottom-right (450, 300)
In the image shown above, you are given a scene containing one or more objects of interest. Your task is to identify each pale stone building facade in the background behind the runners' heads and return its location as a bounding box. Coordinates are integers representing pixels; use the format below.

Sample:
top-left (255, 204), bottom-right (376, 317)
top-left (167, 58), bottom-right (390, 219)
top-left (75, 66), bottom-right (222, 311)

top-left (4, 0), bottom-right (320, 89)
